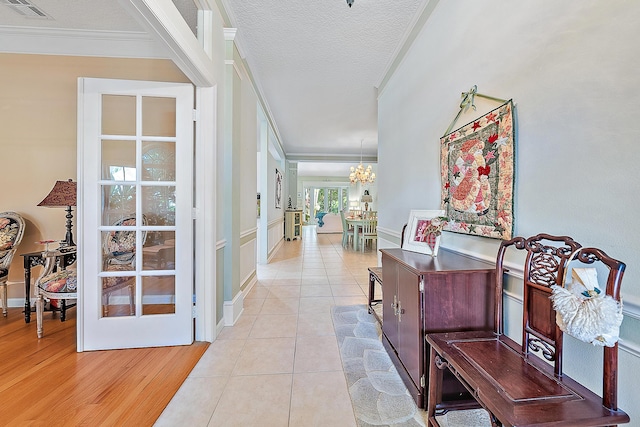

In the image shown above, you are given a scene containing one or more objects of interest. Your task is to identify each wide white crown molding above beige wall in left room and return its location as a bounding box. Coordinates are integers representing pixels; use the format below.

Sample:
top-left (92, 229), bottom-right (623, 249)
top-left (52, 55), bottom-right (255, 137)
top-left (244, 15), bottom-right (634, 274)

top-left (0, 26), bottom-right (169, 59)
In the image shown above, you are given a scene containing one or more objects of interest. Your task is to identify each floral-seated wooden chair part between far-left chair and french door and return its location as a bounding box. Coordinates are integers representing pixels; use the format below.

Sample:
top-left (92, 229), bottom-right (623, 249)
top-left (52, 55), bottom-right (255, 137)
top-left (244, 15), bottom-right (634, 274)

top-left (35, 250), bottom-right (78, 338)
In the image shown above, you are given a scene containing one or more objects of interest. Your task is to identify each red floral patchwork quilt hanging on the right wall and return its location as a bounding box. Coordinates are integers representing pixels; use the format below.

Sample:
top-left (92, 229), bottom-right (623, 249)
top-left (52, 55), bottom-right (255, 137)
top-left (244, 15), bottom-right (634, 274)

top-left (440, 90), bottom-right (515, 240)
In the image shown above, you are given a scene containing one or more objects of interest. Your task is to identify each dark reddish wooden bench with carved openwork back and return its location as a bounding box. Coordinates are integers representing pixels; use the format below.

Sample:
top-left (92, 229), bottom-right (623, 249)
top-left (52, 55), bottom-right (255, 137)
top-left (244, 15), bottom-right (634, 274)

top-left (426, 234), bottom-right (629, 426)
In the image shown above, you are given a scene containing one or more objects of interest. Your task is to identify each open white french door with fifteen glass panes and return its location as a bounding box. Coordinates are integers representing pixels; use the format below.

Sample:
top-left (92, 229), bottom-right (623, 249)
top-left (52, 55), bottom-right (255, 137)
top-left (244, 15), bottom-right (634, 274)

top-left (78, 78), bottom-right (193, 351)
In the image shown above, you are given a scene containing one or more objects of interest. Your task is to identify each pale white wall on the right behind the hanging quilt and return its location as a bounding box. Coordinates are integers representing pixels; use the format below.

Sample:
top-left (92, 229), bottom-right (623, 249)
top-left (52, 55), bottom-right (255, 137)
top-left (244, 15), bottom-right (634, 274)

top-left (378, 0), bottom-right (640, 425)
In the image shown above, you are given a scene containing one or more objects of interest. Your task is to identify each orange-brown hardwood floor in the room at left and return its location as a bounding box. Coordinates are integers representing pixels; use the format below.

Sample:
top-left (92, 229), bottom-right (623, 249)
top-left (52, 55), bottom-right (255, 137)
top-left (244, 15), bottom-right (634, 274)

top-left (0, 308), bottom-right (208, 426)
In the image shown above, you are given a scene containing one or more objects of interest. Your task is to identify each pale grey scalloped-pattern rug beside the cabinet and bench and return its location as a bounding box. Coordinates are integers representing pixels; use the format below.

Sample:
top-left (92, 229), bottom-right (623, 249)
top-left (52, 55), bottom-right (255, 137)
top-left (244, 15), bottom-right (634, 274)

top-left (331, 305), bottom-right (491, 427)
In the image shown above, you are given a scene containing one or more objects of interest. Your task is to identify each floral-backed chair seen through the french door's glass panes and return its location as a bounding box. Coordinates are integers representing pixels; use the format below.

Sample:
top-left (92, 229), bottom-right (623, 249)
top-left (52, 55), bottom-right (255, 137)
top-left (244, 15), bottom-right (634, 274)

top-left (102, 214), bottom-right (147, 317)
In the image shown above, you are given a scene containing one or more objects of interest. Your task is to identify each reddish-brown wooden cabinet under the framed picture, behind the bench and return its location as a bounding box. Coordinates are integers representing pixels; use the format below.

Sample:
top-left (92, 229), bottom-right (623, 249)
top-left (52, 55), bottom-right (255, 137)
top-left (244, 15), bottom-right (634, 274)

top-left (380, 249), bottom-right (495, 409)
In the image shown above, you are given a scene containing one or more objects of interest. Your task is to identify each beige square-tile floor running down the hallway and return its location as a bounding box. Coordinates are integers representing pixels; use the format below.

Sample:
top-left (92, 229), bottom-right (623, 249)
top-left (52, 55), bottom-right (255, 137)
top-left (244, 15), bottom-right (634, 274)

top-left (156, 226), bottom-right (377, 427)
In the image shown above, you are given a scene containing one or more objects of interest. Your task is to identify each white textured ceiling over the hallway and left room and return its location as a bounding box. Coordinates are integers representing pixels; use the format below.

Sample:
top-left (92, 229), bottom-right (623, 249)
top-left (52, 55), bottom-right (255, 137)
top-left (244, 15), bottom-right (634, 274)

top-left (0, 0), bottom-right (428, 175)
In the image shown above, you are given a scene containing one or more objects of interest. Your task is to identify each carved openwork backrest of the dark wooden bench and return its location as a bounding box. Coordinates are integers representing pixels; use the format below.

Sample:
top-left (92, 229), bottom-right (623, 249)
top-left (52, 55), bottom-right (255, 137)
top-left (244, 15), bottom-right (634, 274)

top-left (496, 234), bottom-right (625, 409)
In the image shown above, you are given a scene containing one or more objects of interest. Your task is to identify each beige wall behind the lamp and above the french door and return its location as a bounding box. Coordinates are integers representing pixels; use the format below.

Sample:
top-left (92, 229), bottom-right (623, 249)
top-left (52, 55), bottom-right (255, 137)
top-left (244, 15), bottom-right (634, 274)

top-left (0, 54), bottom-right (188, 298)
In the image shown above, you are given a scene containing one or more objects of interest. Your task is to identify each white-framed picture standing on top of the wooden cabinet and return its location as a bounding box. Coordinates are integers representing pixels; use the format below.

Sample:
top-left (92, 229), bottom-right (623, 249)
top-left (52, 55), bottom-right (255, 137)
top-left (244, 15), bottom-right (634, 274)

top-left (402, 210), bottom-right (447, 256)
